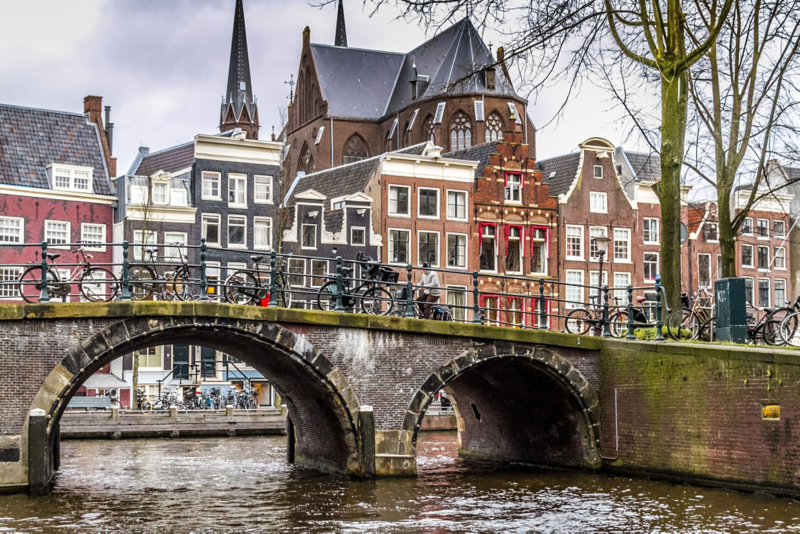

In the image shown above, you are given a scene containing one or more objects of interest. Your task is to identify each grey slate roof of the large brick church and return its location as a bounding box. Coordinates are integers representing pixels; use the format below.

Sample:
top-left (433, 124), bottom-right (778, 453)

top-left (311, 18), bottom-right (516, 120)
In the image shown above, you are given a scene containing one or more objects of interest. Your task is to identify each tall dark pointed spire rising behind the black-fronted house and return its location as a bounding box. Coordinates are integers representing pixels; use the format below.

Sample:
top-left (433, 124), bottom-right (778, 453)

top-left (219, 0), bottom-right (259, 139)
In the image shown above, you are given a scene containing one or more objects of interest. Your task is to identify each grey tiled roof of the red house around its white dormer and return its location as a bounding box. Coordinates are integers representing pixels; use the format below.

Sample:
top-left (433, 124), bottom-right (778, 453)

top-left (0, 104), bottom-right (114, 195)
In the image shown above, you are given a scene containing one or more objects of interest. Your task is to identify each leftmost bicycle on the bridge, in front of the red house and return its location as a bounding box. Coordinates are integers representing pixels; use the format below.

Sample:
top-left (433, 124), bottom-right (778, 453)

top-left (17, 247), bottom-right (119, 304)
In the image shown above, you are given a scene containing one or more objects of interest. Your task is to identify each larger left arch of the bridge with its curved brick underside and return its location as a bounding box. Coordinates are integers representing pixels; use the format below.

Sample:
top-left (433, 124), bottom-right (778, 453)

top-left (31, 317), bottom-right (363, 476)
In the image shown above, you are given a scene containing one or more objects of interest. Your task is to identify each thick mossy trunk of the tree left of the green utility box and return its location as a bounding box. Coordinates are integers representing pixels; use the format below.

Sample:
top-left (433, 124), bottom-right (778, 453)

top-left (658, 67), bottom-right (687, 309)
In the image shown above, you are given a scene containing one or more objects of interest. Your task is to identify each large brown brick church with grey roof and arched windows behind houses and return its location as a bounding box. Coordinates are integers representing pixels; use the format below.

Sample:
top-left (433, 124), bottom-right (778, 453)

top-left (284, 0), bottom-right (535, 180)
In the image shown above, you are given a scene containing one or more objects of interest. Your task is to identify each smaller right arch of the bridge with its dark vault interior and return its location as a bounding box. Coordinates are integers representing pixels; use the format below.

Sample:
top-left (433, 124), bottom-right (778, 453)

top-left (403, 346), bottom-right (602, 468)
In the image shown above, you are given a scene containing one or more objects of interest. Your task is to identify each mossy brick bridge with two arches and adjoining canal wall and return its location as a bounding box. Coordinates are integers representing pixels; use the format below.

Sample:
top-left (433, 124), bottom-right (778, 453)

top-left (0, 302), bottom-right (800, 500)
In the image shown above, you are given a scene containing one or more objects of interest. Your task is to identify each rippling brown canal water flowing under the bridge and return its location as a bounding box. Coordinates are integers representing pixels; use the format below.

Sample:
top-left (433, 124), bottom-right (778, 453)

top-left (0, 433), bottom-right (800, 533)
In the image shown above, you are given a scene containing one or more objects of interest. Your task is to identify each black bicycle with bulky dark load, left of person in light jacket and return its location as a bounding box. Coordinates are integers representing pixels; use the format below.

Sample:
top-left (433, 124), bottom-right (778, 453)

top-left (317, 252), bottom-right (400, 315)
